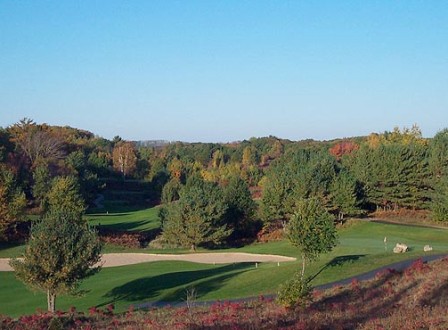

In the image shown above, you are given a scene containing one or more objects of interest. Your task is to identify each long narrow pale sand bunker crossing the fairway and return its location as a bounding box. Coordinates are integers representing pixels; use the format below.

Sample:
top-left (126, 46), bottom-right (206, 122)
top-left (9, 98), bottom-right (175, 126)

top-left (0, 252), bottom-right (296, 272)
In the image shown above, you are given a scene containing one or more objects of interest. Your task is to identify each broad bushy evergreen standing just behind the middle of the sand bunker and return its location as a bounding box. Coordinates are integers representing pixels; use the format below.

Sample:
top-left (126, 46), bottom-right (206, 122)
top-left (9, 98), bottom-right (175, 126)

top-left (161, 176), bottom-right (231, 250)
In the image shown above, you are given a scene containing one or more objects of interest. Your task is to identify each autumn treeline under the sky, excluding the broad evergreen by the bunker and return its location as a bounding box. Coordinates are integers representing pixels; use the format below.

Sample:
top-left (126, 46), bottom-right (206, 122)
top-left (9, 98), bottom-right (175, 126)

top-left (0, 118), bottom-right (448, 240)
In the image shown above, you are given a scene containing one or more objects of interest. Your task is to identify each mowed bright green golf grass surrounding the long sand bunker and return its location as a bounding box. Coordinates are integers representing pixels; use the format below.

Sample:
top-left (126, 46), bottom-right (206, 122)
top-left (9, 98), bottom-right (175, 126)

top-left (0, 221), bottom-right (448, 316)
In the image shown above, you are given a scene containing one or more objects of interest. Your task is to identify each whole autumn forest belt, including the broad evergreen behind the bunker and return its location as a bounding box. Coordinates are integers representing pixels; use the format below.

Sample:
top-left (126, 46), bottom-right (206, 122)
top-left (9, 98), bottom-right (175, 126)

top-left (0, 118), bottom-right (448, 248)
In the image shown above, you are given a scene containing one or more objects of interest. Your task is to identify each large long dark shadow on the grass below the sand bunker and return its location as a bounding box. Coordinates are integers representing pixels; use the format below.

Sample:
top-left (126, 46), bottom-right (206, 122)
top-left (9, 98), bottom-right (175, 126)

top-left (97, 263), bottom-right (253, 307)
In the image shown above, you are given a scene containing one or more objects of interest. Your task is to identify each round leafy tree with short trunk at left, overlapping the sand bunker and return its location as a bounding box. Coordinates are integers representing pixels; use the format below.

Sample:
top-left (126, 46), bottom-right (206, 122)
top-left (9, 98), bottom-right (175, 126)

top-left (10, 210), bottom-right (102, 312)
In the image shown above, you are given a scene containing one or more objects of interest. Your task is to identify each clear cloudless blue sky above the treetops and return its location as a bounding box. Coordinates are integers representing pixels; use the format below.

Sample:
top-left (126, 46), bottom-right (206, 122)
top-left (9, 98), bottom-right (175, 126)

top-left (0, 0), bottom-right (448, 142)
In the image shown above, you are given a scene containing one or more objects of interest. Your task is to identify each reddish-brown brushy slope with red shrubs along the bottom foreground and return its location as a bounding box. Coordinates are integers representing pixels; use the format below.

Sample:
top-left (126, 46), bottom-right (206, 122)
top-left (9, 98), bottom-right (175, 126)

top-left (0, 259), bottom-right (448, 330)
